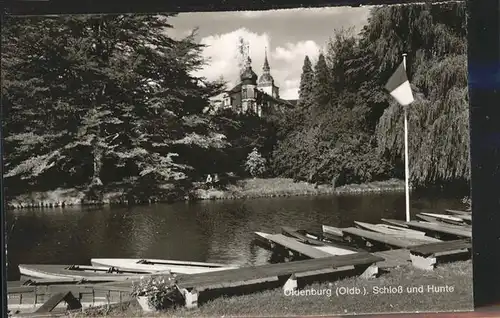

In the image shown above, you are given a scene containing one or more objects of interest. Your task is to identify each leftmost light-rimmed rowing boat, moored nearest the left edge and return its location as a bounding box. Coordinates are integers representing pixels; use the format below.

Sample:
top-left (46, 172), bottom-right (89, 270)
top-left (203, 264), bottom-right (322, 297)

top-left (18, 264), bottom-right (148, 282)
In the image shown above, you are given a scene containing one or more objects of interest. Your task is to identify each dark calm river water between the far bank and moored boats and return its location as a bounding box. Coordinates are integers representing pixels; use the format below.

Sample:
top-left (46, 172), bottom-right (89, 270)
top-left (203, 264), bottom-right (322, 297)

top-left (3, 193), bottom-right (463, 280)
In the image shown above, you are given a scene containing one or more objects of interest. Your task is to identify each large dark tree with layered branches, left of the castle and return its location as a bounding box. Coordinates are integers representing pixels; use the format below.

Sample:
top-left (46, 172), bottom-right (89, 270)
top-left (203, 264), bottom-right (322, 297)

top-left (2, 15), bottom-right (224, 201)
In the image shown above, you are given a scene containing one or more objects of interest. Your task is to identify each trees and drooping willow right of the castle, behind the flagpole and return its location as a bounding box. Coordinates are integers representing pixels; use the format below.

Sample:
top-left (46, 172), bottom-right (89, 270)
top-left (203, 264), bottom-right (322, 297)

top-left (271, 3), bottom-right (469, 190)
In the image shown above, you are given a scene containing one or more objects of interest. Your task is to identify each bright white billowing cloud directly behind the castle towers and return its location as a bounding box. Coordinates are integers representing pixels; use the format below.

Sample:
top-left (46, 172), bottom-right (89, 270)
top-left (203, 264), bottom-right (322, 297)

top-left (196, 28), bottom-right (321, 99)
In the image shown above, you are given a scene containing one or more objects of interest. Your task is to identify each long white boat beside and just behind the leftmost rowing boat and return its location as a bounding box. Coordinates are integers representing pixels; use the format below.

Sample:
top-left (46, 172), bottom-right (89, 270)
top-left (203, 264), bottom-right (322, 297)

top-left (90, 258), bottom-right (238, 274)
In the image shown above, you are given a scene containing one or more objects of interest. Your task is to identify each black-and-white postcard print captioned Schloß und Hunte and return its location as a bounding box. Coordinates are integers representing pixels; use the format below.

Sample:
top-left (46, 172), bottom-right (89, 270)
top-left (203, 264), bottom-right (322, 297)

top-left (1, 2), bottom-right (473, 317)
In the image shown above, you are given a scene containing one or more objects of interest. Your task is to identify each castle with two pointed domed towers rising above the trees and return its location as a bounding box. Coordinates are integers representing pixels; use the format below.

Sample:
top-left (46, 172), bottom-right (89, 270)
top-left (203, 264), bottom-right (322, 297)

top-left (209, 52), bottom-right (296, 117)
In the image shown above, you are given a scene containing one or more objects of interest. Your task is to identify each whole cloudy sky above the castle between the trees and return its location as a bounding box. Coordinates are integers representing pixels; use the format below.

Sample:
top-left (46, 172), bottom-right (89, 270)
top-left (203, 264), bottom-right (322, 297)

top-left (168, 7), bottom-right (369, 99)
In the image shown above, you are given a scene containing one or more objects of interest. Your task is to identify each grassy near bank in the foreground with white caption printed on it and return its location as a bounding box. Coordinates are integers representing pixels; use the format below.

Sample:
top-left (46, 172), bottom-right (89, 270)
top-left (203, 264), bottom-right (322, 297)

top-left (70, 260), bottom-right (472, 317)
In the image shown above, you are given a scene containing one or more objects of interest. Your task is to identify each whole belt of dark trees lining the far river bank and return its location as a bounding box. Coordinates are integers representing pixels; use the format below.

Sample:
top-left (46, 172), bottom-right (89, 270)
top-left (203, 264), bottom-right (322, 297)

top-left (2, 3), bottom-right (469, 204)
